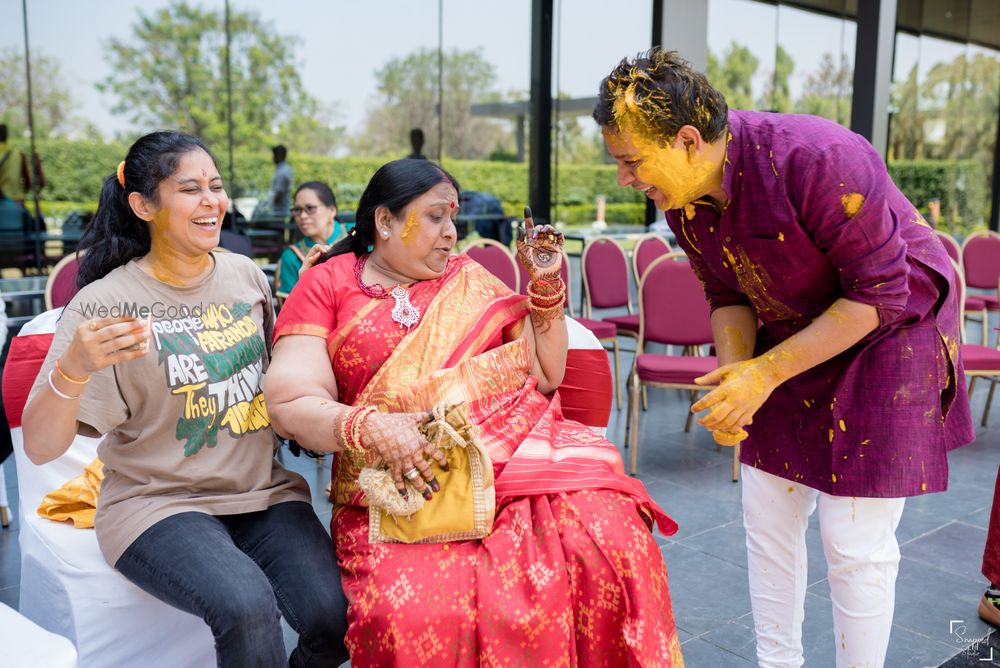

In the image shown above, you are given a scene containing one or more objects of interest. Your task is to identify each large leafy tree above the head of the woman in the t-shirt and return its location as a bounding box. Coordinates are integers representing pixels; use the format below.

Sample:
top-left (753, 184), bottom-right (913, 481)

top-left (98, 2), bottom-right (336, 149)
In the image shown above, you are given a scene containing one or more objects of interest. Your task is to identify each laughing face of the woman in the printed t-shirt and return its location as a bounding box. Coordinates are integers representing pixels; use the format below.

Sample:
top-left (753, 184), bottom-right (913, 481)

top-left (135, 149), bottom-right (229, 258)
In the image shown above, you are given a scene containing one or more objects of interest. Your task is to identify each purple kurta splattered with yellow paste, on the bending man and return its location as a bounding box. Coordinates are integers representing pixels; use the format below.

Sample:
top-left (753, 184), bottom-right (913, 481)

top-left (666, 111), bottom-right (975, 497)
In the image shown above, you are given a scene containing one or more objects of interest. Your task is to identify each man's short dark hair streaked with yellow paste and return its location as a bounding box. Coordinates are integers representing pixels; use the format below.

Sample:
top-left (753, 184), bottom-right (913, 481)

top-left (593, 47), bottom-right (729, 144)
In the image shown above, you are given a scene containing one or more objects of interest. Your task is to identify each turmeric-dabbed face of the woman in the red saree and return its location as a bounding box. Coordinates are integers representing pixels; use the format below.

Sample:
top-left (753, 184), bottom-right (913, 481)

top-left (375, 182), bottom-right (458, 281)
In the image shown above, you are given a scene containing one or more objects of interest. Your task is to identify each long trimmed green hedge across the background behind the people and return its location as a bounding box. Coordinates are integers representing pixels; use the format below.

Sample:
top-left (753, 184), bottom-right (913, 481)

top-left (17, 140), bottom-right (989, 232)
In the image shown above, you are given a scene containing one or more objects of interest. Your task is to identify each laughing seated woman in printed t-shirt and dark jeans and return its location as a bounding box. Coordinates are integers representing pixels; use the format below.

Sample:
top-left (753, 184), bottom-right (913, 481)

top-left (23, 132), bottom-right (347, 668)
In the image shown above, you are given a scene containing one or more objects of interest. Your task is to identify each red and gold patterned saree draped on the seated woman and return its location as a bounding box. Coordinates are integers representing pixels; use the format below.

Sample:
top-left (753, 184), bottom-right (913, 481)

top-left (329, 257), bottom-right (683, 667)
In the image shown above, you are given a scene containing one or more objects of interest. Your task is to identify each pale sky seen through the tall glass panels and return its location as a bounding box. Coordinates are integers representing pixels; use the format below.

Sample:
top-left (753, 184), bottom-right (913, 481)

top-left (0, 0), bottom-right (924, 142)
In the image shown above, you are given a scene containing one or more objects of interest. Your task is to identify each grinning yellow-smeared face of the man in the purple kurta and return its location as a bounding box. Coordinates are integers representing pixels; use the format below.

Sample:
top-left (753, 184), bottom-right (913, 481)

top-left (601, 125), bottom-right (724, 211)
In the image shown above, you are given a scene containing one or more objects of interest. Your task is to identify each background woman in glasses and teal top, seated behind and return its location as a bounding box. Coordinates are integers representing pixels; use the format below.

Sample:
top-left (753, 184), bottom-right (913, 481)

top-left (274, 181), bottom-right (342, 304)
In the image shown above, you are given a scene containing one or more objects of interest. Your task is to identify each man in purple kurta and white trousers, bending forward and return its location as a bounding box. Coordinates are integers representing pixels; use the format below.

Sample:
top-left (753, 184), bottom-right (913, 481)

top-left (594, 49), bottom-right (975, 666)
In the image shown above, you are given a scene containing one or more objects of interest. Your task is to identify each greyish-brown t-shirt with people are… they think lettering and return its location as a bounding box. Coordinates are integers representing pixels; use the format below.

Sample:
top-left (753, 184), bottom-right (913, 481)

top-left (32, 253), bottom-right (309, 565)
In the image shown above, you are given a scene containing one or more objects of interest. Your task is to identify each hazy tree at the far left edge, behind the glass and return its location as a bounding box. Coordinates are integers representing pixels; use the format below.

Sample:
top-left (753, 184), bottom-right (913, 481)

top-left (0, 47), bottom-right (76, 139)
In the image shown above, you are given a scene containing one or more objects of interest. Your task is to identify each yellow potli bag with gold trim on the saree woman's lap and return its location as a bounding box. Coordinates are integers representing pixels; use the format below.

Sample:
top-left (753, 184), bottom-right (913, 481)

top-left (358, 404), bottom-right (496, 543)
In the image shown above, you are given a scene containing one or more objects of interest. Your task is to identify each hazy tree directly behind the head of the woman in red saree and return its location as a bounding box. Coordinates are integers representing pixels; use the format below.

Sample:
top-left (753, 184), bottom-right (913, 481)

top-left (352, 48), bottom-right (509, 159)
